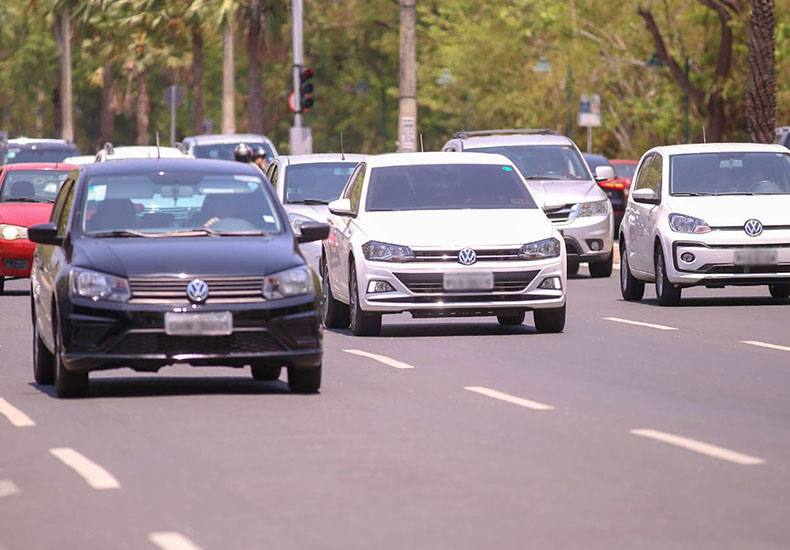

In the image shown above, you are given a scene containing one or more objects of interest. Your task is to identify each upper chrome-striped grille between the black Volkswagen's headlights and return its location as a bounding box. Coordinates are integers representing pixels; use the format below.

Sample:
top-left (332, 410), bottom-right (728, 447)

top-left (129, 277), bottom-right (264, 304)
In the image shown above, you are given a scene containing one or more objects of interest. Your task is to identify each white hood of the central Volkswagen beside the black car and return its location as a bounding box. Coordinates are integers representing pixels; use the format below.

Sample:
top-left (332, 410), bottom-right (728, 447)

top-left (357, 208), bottom-right (554, 248)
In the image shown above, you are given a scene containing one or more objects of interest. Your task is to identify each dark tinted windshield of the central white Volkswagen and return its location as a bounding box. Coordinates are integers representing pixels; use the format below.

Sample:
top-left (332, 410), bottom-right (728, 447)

top-left (366, 164), bottom-right (537, 212)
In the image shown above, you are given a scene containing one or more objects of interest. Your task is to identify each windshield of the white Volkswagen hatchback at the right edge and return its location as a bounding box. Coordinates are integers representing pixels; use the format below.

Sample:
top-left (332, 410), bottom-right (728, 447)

top-left (670, 153), bottom-right (790, 195)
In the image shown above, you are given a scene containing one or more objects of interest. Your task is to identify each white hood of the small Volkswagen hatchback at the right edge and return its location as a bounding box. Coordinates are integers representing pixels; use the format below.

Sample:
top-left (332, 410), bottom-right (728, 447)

top-left (668, 195), bottom-right (790, 227)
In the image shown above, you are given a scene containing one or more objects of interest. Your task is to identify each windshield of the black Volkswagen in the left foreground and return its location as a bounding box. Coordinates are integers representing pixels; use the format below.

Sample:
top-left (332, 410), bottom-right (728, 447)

top-left (82, 172), bottom-right (283, 237)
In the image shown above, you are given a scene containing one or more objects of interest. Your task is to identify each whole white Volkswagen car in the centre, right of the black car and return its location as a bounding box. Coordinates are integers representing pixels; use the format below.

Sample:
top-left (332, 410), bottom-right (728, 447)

top-left (322, 153), bottom-right (566, 335)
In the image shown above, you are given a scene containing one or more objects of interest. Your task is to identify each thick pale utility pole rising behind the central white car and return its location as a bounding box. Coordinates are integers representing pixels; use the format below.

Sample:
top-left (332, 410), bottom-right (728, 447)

top-left (398, 0), bottom-right (417, 153)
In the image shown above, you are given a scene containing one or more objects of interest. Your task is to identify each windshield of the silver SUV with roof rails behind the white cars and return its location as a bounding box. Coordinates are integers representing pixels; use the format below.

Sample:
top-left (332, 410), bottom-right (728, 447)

top-left (467, 145), bottom-right (592, 180)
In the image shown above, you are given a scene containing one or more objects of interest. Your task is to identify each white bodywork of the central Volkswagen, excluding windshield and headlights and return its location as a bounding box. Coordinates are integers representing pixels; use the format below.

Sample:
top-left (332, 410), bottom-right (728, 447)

top-left (324, 153), bottom-right (566, 334)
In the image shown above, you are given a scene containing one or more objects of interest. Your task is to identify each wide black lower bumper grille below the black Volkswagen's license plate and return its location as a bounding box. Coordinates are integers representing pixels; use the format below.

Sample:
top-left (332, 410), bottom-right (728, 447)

top-left (108, 330), bottom-right (283, 357)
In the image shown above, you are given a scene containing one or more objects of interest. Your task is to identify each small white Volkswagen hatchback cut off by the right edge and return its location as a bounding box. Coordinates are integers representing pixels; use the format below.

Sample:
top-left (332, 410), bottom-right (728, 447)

top-left (620, 143), bottom-right (790, 305)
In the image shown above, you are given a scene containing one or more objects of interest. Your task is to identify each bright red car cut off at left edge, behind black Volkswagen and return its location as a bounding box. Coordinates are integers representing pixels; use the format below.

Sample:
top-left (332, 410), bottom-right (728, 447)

top-left (0, 162), bottom-right (76, 293)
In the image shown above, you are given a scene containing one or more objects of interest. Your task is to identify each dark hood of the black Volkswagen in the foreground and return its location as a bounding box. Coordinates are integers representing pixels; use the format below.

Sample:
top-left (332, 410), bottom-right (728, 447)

top-left (72, 234), bottom-right (304, 277)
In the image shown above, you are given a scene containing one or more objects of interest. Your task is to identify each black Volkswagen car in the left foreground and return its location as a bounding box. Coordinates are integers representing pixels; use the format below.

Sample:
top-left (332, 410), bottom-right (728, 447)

top-left (29, 159), bottom-right (328, 397)
